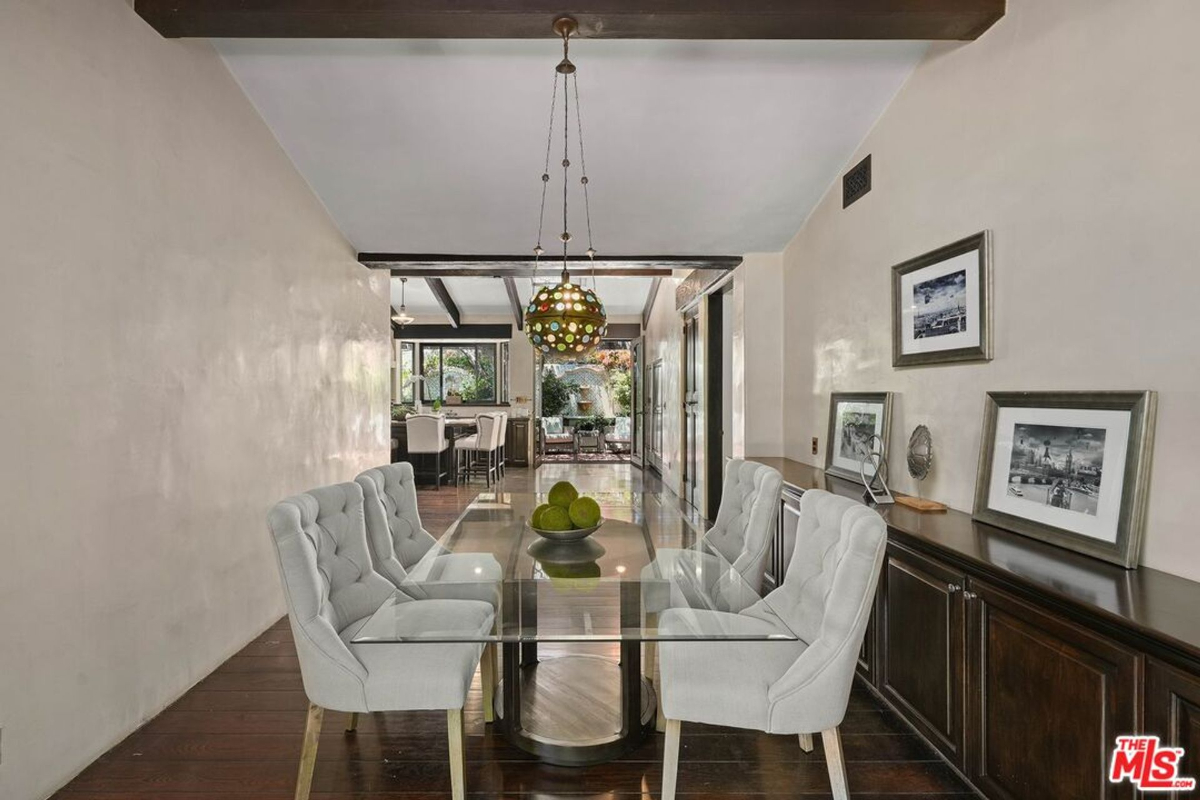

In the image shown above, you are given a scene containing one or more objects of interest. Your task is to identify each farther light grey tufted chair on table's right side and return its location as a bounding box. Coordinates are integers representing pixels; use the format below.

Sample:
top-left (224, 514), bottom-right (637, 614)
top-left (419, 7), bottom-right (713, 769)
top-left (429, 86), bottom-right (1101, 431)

top-left (642, 458), bottom-right (784, 727)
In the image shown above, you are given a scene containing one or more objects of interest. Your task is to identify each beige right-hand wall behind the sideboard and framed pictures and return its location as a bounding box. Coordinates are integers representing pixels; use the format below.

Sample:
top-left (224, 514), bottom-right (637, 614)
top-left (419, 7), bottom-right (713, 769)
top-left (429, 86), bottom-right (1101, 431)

top-left (784, 0), bottom-right (1200, 578)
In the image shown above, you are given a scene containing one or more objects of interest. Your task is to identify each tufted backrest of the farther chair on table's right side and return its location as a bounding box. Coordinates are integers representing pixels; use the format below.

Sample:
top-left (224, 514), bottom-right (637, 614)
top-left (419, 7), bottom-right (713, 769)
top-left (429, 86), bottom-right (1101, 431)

top-left (704, 458), bottom-right (784, 593)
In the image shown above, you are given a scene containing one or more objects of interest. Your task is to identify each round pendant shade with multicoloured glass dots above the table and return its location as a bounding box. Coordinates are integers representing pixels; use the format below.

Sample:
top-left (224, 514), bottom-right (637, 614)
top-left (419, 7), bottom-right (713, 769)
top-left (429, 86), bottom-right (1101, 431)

top-left (526, 281), bottom-right (608, 355)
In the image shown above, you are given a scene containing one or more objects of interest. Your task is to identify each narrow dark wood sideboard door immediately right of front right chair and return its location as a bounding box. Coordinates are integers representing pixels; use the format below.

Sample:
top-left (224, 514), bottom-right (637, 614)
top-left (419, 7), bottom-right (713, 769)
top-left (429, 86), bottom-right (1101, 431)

top-left (876, 543), bottom-right (966, 765)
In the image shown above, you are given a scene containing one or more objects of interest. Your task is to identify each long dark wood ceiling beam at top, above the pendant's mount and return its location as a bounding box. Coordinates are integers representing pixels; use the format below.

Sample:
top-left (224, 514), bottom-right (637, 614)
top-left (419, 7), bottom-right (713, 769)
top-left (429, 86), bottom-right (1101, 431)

top-left (133, 0), bottom-right (1006, 40)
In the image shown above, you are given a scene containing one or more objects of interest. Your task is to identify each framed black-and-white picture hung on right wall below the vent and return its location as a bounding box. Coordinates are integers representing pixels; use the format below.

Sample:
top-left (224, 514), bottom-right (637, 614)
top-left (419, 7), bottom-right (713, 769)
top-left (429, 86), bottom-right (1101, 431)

top-left (892, 230), bottom-right (992, 367)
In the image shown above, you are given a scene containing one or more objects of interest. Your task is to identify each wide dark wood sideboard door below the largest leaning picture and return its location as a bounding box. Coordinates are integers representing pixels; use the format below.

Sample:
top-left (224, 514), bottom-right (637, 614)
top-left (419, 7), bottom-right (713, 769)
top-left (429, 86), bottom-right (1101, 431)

top-left (967, 579), bottom-right (1140, 800)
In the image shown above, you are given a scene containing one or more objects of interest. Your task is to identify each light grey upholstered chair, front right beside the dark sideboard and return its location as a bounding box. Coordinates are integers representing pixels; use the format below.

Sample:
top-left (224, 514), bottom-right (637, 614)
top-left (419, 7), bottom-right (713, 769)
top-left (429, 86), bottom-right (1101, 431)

top-left (659, 489), bottom-right (887, 800)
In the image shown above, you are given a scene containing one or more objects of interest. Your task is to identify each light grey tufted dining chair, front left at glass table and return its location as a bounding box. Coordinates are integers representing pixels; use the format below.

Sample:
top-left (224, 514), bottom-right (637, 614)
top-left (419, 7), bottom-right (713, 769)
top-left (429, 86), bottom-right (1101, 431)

top-left (268, 483), bottom-right (493, 800)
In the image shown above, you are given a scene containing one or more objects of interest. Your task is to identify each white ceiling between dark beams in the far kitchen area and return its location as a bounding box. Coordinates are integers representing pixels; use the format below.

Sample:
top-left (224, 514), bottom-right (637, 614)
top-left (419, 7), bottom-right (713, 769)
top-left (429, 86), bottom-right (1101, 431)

top-left (391, 270), bottom-right (654, 323)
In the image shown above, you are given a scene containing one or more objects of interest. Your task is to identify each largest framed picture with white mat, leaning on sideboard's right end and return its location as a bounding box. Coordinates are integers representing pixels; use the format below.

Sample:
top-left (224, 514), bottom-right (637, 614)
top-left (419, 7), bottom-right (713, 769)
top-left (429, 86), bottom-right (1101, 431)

top-left (974, 391), bottom-right (1157, 569)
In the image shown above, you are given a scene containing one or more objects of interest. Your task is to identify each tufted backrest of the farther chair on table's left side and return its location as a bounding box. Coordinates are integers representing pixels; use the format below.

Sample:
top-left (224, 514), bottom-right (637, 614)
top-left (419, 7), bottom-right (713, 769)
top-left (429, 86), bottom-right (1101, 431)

top-left (354, 462), bottom-right (437, 587)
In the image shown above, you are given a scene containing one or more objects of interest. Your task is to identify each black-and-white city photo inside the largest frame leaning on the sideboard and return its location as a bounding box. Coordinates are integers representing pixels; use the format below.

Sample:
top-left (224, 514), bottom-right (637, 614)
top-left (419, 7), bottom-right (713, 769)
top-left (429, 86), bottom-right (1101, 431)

top-left (1008, 425), bottom-right (1108, 517)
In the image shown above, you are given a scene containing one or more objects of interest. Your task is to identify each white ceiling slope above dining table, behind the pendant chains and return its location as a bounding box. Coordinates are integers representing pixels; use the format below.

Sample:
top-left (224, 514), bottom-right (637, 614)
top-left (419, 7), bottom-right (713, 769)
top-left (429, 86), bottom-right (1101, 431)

top-left (216, 40), bottom-right (925, 253)
